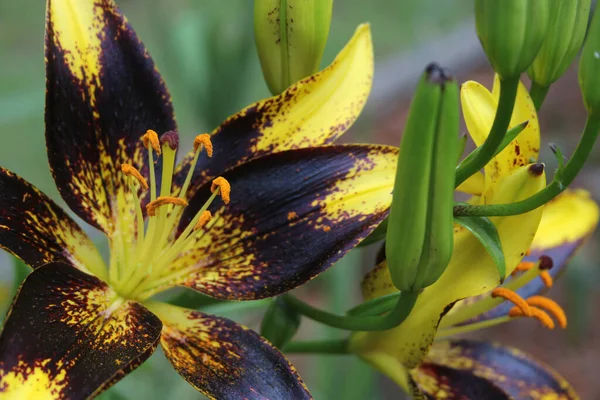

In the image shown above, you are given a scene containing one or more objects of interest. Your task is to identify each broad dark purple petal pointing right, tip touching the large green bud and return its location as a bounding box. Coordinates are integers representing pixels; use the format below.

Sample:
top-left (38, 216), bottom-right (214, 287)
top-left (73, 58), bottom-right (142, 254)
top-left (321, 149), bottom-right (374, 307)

top-left (170, 145), bottom-right (398, 300)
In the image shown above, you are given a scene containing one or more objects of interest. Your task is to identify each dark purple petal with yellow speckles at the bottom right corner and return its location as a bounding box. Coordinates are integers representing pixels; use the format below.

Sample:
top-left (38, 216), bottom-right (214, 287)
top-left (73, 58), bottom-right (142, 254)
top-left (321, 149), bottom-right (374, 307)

top-left (411, 340), bottom-right (579, 400)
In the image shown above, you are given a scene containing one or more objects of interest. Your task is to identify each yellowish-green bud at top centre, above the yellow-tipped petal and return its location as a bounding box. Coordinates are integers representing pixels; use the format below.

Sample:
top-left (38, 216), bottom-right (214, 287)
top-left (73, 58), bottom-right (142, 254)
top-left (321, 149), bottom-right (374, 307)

top-left (254, 0), bottom-right (333, 95)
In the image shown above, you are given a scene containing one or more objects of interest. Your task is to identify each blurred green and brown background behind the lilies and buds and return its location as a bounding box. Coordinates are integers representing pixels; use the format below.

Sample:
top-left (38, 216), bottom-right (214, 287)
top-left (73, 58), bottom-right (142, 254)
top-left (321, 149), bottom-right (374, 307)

top-left (0, 0), bottom-right (600, 400)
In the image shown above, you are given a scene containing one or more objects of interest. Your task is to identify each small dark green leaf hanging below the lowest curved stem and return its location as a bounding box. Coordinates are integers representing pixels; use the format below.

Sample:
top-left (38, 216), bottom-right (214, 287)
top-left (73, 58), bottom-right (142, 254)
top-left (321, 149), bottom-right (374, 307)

top-left (260, 297), bottom-right (300, 349)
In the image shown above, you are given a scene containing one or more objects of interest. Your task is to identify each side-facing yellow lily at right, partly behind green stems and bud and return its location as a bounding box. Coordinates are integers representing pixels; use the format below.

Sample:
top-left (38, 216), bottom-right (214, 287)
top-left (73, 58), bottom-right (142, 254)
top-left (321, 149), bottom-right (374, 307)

top-left (349, 76), bottom-right (598, 398)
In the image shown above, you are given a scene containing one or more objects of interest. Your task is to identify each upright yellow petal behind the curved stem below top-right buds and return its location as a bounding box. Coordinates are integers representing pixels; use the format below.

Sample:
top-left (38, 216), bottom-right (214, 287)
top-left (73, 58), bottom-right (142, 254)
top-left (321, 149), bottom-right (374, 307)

top-left (460, 76), bottom-right (540, 187)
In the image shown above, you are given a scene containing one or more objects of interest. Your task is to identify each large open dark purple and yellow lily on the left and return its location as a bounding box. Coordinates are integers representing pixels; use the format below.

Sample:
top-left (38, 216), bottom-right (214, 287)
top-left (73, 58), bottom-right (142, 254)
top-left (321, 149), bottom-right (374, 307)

top-left (0, 0), bottom-right (397, 399)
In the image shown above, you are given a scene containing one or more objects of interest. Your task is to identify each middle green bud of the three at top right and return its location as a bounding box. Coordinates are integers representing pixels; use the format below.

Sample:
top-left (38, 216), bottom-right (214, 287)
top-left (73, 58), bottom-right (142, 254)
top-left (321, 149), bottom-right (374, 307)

top-left (527, 0), bottom-right (591, 87)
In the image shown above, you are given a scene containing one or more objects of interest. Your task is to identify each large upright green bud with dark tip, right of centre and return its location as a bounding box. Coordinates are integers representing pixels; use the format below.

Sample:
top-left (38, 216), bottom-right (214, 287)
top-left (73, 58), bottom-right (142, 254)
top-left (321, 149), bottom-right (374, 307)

top-left (385, 64), bottom-right (460, 292)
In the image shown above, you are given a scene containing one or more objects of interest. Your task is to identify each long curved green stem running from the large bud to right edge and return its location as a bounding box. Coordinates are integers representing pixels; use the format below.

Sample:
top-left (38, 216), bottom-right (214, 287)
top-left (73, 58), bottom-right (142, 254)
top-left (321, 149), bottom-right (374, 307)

top-left (454, 115), bottom-right (600, 217)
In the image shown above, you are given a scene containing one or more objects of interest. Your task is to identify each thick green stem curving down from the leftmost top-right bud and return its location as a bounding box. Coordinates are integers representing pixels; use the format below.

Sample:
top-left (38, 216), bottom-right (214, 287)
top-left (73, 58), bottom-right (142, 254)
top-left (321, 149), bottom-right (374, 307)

top-left (455, 77), bottom-right (519, 187)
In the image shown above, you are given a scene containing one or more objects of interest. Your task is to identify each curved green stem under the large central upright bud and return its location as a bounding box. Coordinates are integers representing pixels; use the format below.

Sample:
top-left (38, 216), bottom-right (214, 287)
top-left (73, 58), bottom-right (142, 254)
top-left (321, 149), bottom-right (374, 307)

top-left (284, 291), bottom-right (419, 331)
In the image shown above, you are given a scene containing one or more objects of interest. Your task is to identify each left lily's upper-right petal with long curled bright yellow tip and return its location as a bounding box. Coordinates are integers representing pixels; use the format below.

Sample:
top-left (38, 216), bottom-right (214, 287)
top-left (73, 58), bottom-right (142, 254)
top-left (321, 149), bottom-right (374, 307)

top-left (173, 24), bottom-right (373, 202)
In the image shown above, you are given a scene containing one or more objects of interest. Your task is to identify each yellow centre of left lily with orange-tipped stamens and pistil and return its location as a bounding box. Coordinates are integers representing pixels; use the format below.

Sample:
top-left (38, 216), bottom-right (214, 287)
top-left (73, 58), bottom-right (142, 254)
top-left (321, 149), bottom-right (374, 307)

top-left (109, 130), bottom-right (231, 300)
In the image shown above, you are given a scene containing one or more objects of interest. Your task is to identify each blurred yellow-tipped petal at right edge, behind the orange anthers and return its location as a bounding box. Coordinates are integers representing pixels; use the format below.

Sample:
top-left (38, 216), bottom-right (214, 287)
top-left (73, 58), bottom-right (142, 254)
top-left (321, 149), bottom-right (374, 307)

top-left (465, 189), bottom-right (599, 323)
